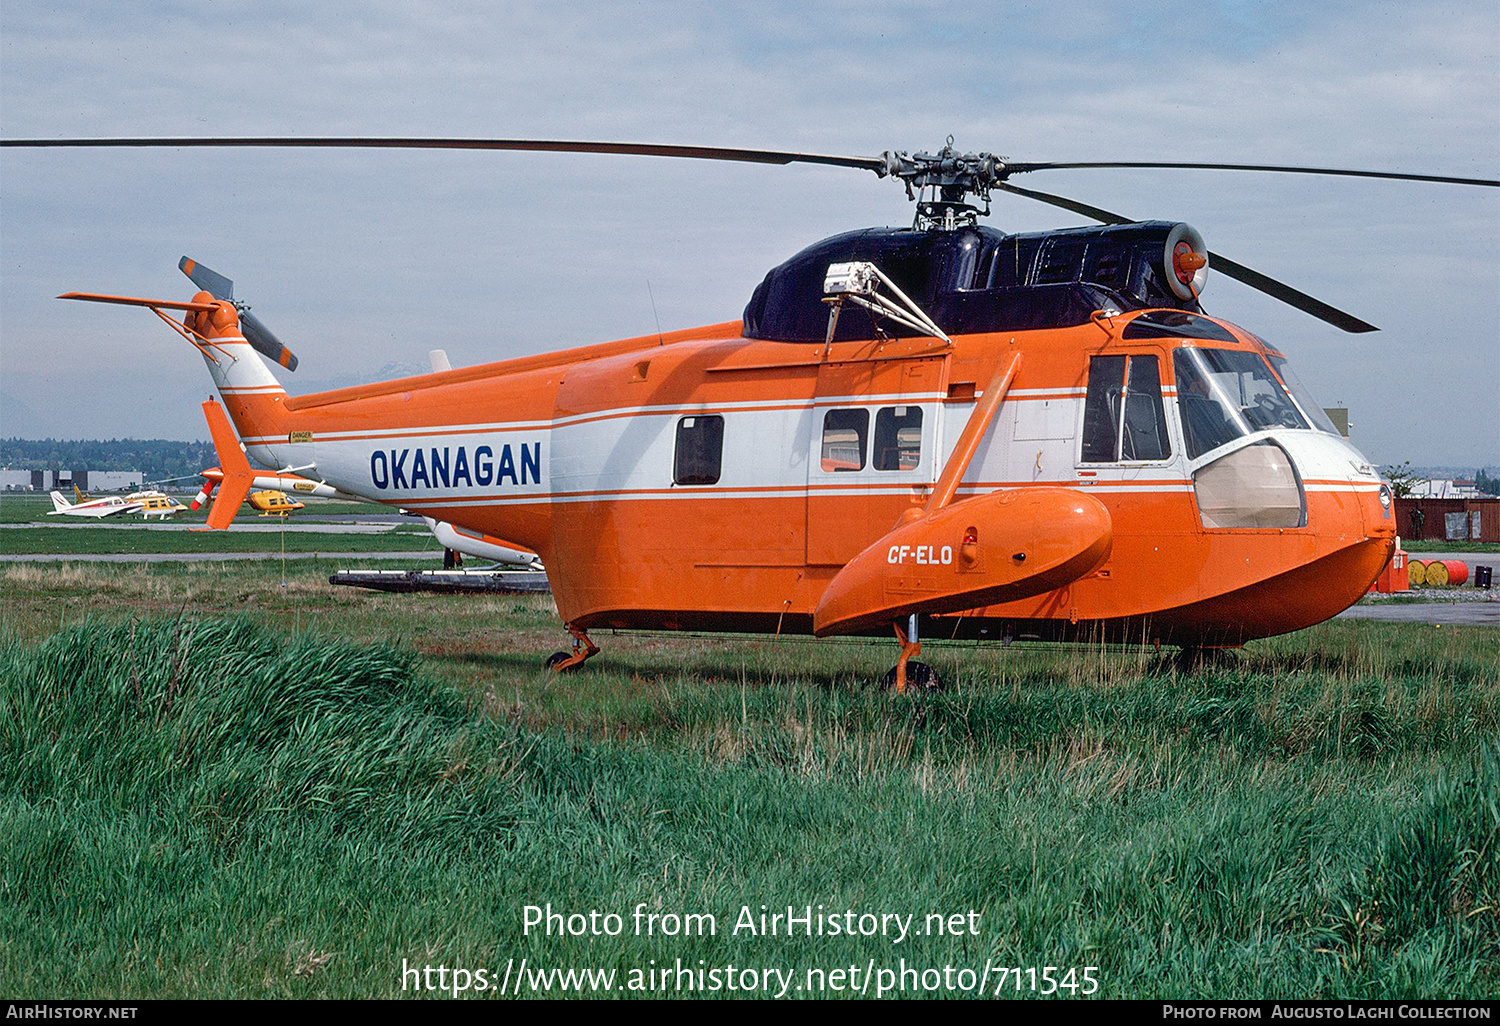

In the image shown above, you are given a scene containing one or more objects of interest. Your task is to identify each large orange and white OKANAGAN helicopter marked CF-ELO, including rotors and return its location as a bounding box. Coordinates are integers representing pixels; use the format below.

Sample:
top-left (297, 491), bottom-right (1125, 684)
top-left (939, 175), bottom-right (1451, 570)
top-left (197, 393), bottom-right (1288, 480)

top-left (14, 138), bottom-right (1500, 692)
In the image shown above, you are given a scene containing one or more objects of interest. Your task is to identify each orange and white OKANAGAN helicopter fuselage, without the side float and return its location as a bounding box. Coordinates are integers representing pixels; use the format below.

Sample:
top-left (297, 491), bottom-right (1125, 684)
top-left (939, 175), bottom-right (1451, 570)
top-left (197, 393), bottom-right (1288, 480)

top-left (214, 311), bottom-right (1395, 644)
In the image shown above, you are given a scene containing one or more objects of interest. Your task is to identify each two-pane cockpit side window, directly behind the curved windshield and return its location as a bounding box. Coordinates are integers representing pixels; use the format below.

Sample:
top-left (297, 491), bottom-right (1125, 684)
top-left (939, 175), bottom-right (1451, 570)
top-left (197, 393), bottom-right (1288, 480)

top-left (1082, 354), bottom-right (1172, 464)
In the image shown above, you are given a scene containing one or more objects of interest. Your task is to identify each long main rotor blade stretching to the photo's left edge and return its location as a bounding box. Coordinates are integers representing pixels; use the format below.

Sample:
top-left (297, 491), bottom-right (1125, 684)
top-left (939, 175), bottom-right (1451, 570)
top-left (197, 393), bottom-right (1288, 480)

top-left (0, 135), bottom-right (885, 174)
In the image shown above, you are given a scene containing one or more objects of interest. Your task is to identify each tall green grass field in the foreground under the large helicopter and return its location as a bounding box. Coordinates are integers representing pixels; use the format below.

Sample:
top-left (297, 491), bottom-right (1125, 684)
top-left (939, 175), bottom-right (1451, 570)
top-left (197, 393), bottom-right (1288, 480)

top-left (0, 560), bottom-right (1500, 998)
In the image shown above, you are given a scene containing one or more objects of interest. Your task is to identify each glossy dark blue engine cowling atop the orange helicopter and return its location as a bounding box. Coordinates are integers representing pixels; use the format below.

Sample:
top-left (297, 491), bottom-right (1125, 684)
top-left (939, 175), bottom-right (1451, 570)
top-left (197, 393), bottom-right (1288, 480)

top-left (744, 221), bottom-right (1202, 342)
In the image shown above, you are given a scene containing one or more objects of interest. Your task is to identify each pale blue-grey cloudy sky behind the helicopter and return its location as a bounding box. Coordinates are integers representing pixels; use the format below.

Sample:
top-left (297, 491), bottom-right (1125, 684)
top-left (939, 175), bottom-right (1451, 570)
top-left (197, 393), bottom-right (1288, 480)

top-left (0, 0), bottom-right (1500, 467)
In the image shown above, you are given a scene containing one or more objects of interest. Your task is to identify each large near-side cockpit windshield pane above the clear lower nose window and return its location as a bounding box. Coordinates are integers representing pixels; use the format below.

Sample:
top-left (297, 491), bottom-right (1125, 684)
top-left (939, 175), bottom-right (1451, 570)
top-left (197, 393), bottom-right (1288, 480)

top-left (1172, 348), bottom-right (1308, 459)
